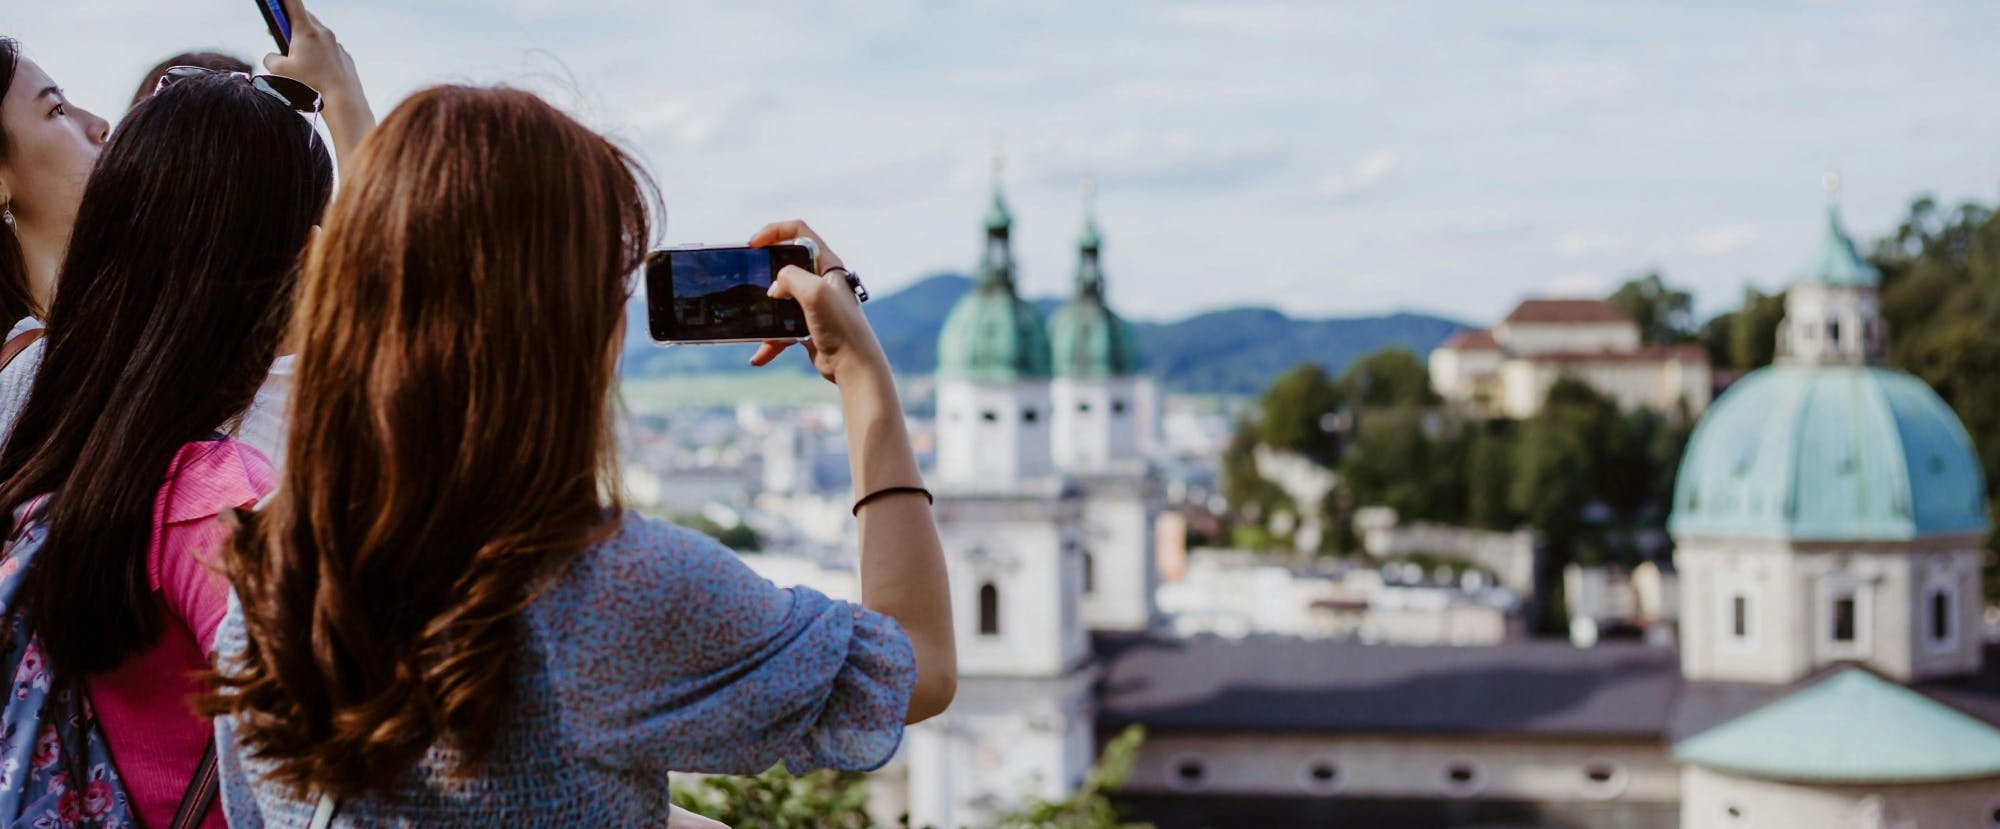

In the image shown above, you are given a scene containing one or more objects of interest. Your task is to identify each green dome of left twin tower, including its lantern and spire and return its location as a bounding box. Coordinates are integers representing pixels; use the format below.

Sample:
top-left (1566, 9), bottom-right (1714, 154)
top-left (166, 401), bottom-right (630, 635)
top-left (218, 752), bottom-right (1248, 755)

top-left (938, 186), bottom-right (1050, 382)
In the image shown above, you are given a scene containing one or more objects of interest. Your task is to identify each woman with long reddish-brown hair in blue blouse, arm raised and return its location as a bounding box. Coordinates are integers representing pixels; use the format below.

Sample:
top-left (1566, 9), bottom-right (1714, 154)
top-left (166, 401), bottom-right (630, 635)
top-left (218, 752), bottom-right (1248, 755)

top-left (210, 86), bottom-right (956, 827)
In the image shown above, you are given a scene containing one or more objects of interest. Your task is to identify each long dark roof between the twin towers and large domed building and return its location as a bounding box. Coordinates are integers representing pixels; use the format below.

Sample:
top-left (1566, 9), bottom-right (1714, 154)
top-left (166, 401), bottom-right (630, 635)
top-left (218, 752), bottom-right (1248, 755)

top-left (1096, 637), bottom-right (1682, 739)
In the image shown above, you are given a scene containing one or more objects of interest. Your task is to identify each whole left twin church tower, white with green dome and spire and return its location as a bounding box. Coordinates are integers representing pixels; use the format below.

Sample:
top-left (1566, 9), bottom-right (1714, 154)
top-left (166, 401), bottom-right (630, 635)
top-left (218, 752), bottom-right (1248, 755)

top-left (906, 173), bottom-right (1094, 827)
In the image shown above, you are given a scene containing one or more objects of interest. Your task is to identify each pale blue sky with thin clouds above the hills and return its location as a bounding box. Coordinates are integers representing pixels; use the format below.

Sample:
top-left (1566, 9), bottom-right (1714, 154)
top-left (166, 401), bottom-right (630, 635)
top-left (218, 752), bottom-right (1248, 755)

top-left (15, 0), bottom-right (2000, 322)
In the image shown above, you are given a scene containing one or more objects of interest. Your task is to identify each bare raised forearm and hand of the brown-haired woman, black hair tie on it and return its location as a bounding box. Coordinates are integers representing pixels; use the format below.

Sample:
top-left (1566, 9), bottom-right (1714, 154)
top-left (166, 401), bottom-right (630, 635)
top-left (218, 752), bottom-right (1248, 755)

top-left (750, 222), bottom-right (958, 723)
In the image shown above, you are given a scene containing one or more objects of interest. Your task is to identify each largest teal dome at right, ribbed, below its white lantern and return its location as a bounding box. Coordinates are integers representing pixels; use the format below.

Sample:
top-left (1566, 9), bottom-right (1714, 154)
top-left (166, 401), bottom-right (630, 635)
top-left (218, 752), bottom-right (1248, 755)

top-left (1668, 366), bottom-right (1988, 541)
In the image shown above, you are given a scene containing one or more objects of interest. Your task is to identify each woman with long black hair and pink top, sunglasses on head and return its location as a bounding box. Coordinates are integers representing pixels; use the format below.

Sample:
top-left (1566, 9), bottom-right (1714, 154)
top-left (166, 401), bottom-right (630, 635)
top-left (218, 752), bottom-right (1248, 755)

top-left (0, 72), bottom-right (334, 827)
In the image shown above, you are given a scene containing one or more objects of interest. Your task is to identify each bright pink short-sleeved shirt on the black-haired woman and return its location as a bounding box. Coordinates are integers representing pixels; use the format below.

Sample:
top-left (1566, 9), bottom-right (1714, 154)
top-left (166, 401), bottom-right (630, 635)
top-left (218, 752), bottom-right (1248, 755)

top-left (90, 441), bottom-right (276, 829)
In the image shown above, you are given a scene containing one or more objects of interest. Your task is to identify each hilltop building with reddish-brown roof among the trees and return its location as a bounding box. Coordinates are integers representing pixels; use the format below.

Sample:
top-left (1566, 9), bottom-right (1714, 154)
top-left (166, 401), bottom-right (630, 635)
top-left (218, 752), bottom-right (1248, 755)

top-left (1430, 298), bottom-right (1714, 419)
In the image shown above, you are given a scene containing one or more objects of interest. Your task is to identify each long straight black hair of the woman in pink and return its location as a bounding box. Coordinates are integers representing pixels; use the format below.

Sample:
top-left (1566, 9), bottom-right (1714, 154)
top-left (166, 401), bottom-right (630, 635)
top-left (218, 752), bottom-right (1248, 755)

top-left (0, 76), bottom-right (334, 677)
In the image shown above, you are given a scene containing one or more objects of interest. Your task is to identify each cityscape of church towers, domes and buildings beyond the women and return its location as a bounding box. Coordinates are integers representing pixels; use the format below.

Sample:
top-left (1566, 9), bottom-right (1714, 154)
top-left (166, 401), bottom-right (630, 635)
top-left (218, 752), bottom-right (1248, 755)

top-left (626, 176), bottom-right (2000, 829)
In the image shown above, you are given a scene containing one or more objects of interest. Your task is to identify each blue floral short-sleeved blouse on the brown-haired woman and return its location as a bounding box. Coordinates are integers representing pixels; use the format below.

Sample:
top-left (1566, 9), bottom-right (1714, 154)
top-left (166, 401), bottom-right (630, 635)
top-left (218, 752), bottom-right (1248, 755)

top-left (216, 515), bottom-right (916, 829)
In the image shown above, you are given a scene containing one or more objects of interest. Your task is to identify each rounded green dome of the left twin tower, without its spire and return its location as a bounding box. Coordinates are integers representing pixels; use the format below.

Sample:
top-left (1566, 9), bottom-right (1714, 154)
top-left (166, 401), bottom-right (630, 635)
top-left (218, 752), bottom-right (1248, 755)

top-left (938, 282), bottom-right (1050, 382)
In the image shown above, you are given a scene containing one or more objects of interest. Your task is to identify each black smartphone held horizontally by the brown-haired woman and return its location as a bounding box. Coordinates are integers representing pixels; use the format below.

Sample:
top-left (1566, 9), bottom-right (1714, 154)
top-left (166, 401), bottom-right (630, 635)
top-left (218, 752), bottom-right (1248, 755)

top-left (646, 244), bottom-right (814, 344)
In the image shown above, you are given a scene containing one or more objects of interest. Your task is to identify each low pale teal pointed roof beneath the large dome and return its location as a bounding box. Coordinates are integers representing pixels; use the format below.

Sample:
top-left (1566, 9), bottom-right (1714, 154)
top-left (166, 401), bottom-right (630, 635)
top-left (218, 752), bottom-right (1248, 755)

top-left (1674, 667), bottom-right (2000, 783)
